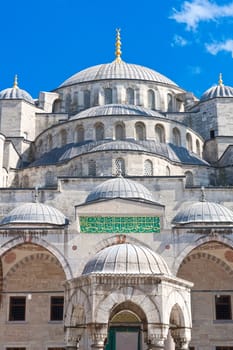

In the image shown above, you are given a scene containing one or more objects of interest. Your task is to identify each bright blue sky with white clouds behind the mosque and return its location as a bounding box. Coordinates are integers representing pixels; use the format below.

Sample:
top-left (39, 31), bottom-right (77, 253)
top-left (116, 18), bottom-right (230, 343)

top-left (0, 0), bottom-right (233, 98)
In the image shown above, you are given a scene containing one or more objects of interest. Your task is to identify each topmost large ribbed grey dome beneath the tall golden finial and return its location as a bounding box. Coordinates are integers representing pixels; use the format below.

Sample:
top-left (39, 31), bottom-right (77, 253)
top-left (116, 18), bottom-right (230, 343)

top-left (60, 60), bottom-right (177, 87)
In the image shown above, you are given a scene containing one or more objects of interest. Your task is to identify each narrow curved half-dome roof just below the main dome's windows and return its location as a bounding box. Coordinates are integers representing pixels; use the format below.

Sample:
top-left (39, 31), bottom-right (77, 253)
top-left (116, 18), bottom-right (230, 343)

top-left (70, 103), bottom-right (164, 119)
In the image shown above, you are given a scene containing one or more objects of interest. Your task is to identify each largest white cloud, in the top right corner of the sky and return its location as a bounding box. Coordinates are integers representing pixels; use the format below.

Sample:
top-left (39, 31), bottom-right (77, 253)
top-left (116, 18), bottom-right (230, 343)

top-left (170, 0), bottom-right (233, 30)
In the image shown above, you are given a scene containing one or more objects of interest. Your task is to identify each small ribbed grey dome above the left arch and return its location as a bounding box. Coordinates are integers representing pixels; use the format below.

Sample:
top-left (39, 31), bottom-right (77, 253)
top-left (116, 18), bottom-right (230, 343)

top-left (0, 203), bottom-right (68, 226)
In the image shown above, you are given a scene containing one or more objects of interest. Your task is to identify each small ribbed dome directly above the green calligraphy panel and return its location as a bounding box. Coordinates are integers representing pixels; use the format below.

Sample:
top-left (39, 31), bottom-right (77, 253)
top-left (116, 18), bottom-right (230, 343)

top-left (86, 176), bottom-right (154, 203)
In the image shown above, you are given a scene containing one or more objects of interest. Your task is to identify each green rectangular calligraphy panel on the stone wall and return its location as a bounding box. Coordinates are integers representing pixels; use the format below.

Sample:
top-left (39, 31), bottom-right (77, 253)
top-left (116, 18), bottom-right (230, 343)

top-left (79, 216), bottom-right (160, 233)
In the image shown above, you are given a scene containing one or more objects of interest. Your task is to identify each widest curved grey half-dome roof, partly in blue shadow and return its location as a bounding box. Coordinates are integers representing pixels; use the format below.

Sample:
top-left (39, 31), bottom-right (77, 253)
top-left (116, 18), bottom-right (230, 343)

top-left (29, 140), bottom-right (208, 167)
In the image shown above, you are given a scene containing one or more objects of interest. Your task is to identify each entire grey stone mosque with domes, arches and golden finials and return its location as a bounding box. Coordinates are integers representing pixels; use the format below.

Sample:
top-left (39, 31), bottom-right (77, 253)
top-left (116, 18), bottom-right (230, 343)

top-left (0, 31), bottom-right (233, 350)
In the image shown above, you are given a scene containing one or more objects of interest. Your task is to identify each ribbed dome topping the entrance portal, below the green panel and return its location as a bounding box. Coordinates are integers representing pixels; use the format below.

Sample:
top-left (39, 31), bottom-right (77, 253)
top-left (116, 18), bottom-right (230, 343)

top-left (82, 243), bottom-right (171, 275)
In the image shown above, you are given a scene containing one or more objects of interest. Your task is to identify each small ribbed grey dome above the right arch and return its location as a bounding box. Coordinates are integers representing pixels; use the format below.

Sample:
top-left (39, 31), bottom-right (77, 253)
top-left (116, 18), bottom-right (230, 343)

top-left (172, 201), bottom-right (233, 224)
